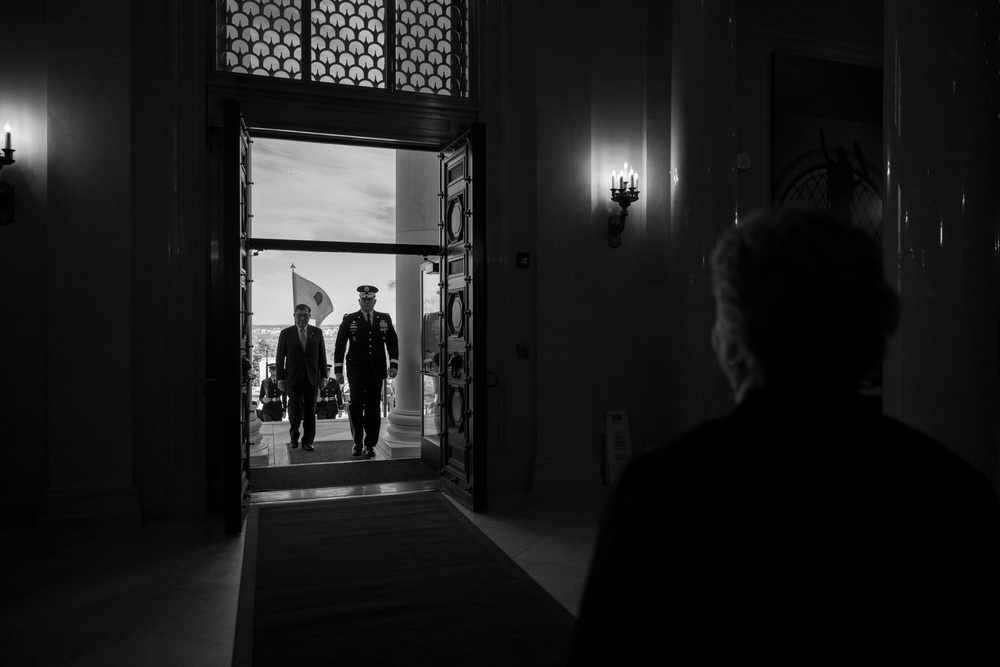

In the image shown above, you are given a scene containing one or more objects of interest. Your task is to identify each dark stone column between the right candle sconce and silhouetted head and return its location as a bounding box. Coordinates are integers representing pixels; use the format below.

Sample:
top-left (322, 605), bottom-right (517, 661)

top-left (659, 0), bottom-right (738, 433)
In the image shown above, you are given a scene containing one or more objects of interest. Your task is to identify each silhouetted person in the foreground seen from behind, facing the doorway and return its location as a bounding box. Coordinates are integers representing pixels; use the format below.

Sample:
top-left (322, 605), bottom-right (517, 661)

top-left (570, 209), bottom-right (1000, 665)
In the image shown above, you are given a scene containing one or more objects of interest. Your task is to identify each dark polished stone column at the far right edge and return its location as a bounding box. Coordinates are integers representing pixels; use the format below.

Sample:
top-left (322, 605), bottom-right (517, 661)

top-left (882, 0), bottom-right (1000, 485)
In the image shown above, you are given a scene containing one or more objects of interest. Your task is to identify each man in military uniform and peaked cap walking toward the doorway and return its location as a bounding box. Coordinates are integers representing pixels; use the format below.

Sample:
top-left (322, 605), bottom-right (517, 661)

top-left (333, 285), bottom-right (399, 457)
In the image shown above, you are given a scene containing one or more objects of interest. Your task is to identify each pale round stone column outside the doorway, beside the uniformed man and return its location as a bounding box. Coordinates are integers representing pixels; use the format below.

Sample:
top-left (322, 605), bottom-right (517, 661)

top-left (379, 151), bottom-right (440, 459)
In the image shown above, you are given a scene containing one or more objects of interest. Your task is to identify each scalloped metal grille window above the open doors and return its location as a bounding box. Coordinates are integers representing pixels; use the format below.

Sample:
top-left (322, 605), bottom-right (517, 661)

top-left (216, 0), bottom-right (469, 97)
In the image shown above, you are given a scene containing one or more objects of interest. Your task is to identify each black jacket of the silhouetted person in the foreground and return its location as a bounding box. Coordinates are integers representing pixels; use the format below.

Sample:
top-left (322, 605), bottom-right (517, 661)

top-left (570, 389), bottom-right (1000, 665)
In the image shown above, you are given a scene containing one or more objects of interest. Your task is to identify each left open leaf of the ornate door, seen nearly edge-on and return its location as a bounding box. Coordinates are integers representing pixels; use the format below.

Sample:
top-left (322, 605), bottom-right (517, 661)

top-left (208, 100), bottom-right (253, 533)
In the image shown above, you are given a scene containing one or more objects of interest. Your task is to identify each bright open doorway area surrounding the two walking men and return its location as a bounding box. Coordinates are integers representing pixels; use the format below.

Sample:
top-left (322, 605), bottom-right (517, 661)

top-left (249, 138), bottom-right (440, 492)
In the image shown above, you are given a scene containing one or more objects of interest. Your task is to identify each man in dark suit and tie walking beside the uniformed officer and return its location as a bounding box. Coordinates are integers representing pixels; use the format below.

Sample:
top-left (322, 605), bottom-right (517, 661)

top-left (274, 303), bottom-right (327, 452)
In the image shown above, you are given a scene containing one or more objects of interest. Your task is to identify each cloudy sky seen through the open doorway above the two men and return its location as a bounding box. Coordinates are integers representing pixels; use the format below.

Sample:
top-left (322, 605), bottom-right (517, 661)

top-left (251, 139), bottom-right (396, 325)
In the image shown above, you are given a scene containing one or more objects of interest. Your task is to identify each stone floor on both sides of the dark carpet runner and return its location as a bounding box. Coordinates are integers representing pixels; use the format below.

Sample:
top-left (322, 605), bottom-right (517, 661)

top-left (0, 485), bottom-right (604, 667)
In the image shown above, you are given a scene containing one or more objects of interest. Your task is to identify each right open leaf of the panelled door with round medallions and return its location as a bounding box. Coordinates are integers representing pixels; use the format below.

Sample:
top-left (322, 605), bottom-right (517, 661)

top-left (438, 125), bottom-right (486, 512)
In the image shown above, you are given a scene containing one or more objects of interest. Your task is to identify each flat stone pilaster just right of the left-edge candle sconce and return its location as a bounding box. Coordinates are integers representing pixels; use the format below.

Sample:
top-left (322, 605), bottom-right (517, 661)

top-left (36, 3), bottom-right (142, 525)
